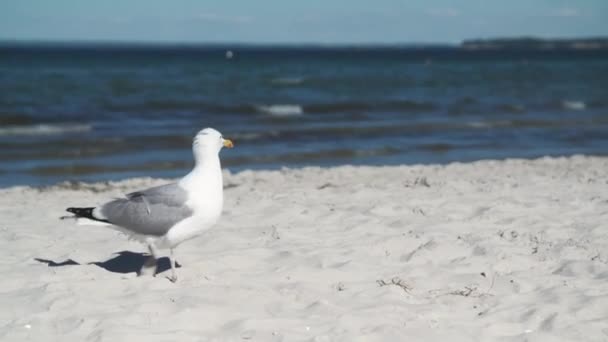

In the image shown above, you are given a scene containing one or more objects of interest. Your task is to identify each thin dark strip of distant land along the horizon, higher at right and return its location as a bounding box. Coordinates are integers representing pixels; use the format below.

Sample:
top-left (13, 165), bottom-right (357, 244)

top-left (0, 37), bottom-right (608, 51)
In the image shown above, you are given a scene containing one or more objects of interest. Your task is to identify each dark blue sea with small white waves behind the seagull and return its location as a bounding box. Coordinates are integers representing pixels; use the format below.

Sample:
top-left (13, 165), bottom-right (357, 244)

top-left (0, 43), bottom-right (608, 187)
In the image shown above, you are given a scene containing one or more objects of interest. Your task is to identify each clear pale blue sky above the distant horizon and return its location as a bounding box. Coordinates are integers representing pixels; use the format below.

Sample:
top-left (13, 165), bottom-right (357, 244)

top-left (0, 0), bottom-right (608, 44)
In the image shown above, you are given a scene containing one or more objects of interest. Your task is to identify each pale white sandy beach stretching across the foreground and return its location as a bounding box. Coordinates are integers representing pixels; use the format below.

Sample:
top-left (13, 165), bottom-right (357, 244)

top-left (0, 156), bottom-right (608, 342)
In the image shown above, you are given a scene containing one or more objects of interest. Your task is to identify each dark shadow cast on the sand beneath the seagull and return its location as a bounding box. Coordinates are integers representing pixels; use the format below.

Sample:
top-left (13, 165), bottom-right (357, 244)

top-left (34, 251), bottom-right (181, 274)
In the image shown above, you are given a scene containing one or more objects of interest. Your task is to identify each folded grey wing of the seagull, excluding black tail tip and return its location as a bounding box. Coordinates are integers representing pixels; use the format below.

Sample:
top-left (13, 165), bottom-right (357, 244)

top-left (101, 183), bottom-right (192, 236)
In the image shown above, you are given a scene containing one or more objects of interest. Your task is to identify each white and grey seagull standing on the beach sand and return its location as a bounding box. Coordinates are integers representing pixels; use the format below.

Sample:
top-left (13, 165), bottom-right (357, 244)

top-left (66, 128), bottom-right (233, 282)
